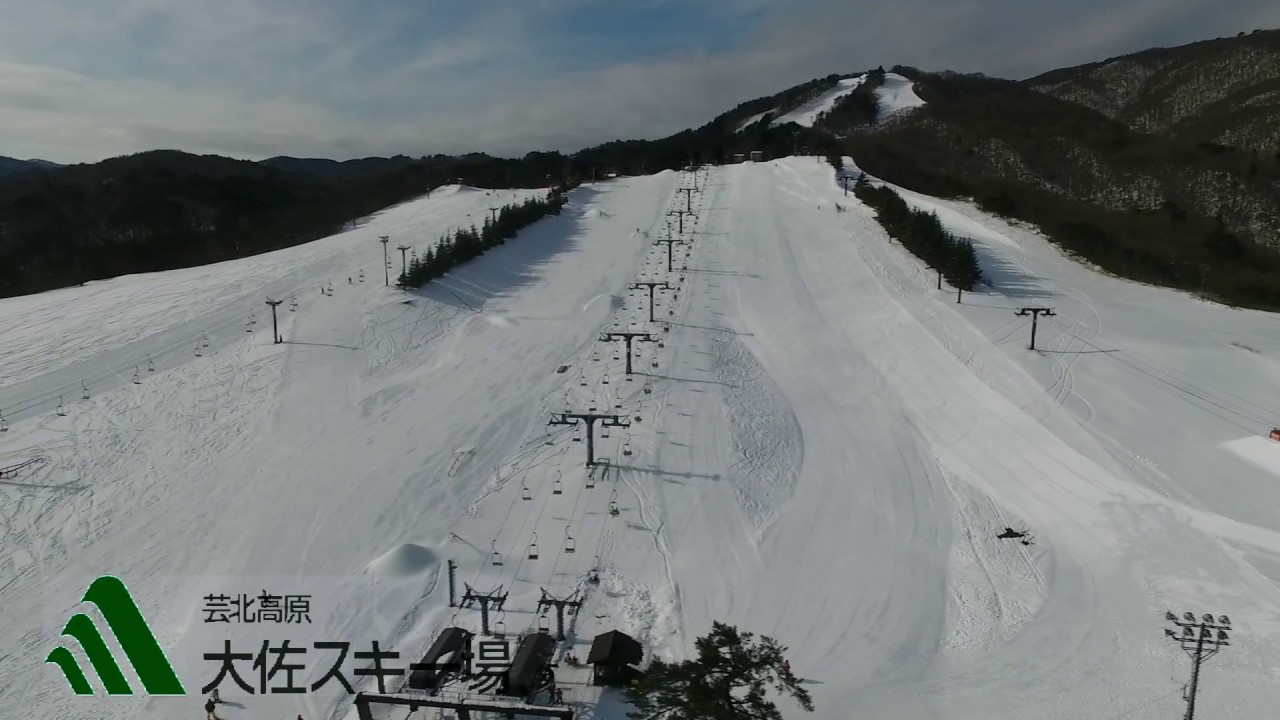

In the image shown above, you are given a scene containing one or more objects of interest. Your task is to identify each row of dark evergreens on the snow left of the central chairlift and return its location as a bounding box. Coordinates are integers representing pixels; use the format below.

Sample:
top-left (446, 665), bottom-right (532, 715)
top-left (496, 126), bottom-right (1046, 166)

top-left (397, 186), bottom-right (570, 288)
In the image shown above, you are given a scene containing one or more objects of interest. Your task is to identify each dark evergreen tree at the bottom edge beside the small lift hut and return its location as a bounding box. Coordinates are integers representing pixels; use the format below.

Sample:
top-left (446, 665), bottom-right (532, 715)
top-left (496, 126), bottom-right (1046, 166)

top-left (626, 623), bottom-right (813, 720)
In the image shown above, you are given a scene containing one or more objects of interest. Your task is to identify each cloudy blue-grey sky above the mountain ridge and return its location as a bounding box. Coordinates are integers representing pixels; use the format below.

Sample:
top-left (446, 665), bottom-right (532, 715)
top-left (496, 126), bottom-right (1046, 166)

top-left (0, 0), bottom-right (1280, 163)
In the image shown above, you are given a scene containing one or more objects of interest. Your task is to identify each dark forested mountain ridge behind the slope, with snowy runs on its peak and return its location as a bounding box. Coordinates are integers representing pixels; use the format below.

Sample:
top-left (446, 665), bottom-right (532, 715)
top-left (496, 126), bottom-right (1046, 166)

top-left (0, 25), bottom-right (1280, 302)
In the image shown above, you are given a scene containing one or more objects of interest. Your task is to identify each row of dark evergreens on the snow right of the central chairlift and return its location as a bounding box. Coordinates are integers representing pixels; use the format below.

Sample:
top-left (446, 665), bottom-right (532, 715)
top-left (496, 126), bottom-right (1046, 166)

top-left (854, 176), bottom-right (982, 291)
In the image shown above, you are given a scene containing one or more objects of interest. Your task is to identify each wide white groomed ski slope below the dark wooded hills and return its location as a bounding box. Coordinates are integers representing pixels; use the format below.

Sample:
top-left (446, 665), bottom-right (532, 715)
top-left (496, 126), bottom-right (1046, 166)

top-left (0, 158), bottom-right (1280, 720)
